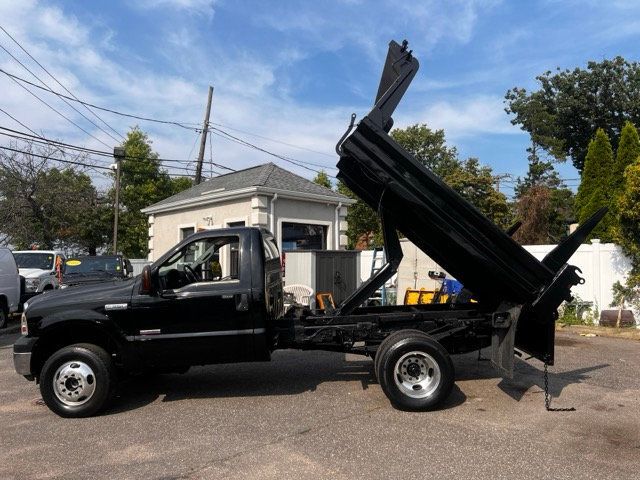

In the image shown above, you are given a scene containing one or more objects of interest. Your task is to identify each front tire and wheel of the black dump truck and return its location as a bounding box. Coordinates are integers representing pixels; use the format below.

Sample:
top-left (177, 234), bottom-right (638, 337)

top-left (40, 343), bottom-right (116, 418)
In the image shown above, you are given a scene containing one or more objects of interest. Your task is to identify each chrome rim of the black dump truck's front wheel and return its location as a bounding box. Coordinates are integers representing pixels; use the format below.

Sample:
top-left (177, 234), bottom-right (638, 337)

top-left (53, 360), bottom-right (96, 407)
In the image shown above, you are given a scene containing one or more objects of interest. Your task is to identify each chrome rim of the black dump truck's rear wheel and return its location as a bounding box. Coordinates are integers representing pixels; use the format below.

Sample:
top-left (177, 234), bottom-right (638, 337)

top-left (394, 351), bottom-right (442, 398)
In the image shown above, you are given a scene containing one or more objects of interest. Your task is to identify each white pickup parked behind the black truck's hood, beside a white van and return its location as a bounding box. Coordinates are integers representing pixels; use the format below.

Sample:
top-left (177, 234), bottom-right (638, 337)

top-left (13, 250), bottom-right (66, 303)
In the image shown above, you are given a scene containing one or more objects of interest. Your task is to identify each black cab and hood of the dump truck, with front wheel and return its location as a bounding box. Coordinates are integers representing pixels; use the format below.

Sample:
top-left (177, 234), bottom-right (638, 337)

top-left (14, 227), bottom-right (284, 416)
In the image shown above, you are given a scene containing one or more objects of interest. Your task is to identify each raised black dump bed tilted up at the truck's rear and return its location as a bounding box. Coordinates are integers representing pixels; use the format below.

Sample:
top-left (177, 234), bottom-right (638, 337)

top-left (337, 41), bottom-right (606, 370)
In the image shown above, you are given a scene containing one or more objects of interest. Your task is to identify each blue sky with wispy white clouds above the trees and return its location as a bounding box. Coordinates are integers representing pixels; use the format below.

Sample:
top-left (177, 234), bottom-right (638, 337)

top-left (0, 0), bottom-right (640, 195)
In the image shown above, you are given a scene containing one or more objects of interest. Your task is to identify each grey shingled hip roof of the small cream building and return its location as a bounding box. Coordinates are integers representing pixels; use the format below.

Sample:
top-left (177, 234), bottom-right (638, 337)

top-left (143, 163), bottom-right (352, 212)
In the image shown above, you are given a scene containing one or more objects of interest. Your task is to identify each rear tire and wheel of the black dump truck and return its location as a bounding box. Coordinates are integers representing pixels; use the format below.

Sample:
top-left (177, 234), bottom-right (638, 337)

top-left (378, 330), bottom-right (455, 411)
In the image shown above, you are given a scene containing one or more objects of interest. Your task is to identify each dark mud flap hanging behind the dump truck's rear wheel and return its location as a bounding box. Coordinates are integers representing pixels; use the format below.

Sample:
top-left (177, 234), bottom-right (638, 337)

top-left (491, 304), bottom-right (522, 378)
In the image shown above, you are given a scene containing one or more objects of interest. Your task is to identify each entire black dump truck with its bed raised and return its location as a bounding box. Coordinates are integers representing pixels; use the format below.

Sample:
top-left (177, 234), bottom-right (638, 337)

top-left (13, 41), bottom-right (605, 417)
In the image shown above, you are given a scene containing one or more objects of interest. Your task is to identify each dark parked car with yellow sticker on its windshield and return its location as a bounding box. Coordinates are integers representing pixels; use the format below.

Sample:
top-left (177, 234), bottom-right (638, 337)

top-left (60, 255), bottom-right (133, 288)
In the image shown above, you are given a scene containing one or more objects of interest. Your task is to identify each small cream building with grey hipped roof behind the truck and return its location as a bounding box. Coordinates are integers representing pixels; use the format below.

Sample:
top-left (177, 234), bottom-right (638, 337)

top-left (142, 163), bottom-right (355, 260)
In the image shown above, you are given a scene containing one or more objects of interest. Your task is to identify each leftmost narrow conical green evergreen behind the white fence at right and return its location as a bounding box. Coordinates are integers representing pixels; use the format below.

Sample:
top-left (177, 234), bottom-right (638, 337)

top-left (575, 128), bottom-right (614, 242)
